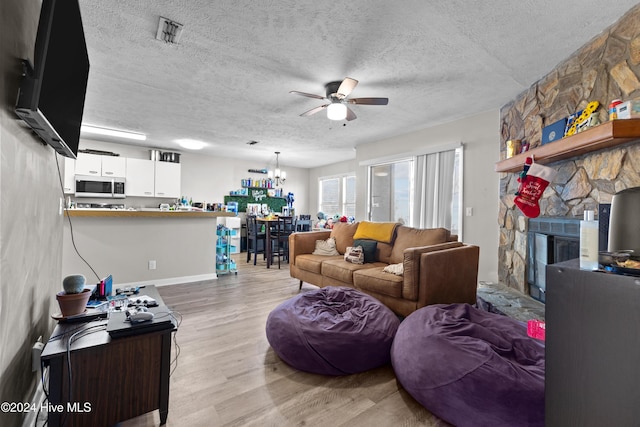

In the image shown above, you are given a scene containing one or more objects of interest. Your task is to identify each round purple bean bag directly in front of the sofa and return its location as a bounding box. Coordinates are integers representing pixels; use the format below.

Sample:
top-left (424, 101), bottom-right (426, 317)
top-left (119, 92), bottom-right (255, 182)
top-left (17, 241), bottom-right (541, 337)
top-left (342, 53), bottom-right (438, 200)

top-left (266, 286), bottom-right (400, 375)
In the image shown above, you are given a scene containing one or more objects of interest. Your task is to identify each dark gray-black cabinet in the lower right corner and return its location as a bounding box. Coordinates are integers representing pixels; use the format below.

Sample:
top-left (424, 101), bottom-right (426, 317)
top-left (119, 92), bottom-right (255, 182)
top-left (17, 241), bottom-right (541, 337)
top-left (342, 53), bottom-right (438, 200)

top-left (545, 259), bottom-right (640, 427)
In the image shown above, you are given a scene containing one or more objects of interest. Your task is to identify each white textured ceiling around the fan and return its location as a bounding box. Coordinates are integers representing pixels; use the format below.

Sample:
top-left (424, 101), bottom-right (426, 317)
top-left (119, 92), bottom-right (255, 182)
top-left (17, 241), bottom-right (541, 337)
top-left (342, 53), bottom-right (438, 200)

top-left (80, 0), bottom-right (636, 167)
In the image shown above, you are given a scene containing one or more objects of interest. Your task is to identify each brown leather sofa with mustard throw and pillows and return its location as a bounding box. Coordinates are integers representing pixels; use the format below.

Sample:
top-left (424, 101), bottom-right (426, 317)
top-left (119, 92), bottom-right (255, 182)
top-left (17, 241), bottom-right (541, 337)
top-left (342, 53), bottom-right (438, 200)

top-left (289, 223), bottom-right (479, 316)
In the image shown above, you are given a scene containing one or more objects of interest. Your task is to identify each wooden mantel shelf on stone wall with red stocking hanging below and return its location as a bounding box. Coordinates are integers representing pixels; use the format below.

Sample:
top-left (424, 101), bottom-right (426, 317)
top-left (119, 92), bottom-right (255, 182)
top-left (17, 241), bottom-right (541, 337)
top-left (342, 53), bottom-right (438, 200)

top-left (495, 119), bottom-right (640, 172)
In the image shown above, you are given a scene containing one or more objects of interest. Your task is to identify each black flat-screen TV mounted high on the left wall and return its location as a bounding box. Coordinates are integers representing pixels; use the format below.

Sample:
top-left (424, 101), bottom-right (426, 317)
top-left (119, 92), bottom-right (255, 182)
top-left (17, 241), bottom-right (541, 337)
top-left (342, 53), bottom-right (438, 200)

top-left (16, 0), bottom-right (89, 158)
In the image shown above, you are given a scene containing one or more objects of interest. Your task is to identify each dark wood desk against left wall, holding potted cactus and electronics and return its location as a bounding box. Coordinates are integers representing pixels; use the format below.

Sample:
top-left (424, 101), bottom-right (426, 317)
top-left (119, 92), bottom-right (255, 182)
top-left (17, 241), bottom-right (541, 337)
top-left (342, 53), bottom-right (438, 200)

top-left (42, 286), bottom-right (176, 427)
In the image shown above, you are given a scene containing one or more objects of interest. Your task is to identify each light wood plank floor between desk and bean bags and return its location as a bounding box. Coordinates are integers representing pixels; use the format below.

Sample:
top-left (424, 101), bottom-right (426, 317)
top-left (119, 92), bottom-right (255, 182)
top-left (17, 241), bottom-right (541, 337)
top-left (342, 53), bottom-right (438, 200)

top-left (121, 254), bottom-right (449, 427)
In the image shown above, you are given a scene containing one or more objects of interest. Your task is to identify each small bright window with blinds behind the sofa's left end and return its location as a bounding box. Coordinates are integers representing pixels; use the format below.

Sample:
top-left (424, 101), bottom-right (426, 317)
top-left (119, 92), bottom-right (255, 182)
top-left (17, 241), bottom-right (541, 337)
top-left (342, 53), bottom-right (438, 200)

top-left (318, 175), bottom-right (356, 217)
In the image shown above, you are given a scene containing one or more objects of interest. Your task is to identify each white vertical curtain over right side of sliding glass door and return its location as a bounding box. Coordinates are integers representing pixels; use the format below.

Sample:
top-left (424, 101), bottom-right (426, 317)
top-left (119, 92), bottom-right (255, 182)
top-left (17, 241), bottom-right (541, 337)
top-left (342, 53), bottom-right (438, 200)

top-left (413, 149), bottom-right (457, 230)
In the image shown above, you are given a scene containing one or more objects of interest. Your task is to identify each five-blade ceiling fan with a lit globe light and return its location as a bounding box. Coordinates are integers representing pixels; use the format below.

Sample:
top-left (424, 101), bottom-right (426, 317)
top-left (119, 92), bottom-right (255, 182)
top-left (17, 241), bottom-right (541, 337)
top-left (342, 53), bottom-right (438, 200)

top-left (289, 77), bottom-right (389, 121)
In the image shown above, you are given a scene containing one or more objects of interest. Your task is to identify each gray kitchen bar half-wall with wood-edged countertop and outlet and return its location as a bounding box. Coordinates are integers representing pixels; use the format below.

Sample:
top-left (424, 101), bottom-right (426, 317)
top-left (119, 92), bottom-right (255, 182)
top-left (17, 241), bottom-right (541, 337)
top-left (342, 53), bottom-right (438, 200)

top-left (62, 209), bottom-right (235, 288)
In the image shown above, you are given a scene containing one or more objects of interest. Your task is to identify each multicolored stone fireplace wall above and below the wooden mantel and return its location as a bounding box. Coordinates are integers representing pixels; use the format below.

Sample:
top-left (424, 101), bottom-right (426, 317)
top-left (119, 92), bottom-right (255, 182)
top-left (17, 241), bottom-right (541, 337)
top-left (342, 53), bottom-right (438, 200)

top-left (498, 5), bottom-right (640, 293)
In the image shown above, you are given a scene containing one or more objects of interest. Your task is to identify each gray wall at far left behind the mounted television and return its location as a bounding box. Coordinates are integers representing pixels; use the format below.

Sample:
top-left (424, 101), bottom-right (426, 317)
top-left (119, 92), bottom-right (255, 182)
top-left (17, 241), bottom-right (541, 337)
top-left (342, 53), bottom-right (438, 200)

top-left (0, 0), bottom-right (62, 426)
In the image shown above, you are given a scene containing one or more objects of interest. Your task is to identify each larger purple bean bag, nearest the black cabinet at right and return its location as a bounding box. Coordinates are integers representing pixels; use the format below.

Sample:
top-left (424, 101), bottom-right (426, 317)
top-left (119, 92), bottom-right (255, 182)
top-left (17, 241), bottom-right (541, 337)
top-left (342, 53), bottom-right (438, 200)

top-left (391, 304), bottom-right (544, 427)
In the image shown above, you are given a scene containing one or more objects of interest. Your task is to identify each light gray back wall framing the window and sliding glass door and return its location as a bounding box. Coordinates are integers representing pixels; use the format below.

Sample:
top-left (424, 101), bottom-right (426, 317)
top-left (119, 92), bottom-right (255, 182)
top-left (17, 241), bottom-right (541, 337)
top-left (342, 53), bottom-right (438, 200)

top-left (309, 110), bottom-right (500, 282)
